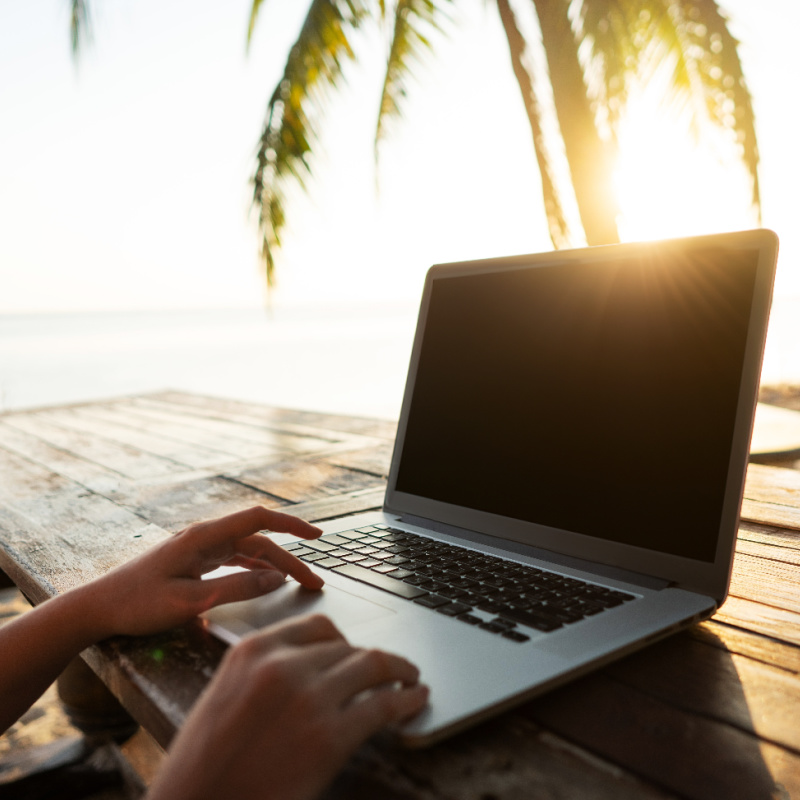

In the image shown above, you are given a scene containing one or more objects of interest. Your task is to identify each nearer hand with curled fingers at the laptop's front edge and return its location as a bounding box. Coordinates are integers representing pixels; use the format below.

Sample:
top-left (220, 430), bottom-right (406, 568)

top-left (147, 615), bottom-right (428, 800)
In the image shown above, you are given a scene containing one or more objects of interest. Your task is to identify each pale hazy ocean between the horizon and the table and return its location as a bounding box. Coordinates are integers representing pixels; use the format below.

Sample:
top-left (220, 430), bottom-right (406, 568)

top-left (0, 298), bottom-right (800, 419)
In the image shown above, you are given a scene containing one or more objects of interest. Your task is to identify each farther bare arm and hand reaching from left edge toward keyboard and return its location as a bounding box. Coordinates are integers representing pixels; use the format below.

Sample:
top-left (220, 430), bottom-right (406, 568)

top-left (0, 507), bottom-right (322, 731)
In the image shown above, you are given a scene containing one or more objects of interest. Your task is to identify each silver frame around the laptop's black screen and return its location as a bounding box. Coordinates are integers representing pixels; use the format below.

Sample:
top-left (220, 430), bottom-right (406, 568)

top-left (384, 229), bottom-right (778, 603)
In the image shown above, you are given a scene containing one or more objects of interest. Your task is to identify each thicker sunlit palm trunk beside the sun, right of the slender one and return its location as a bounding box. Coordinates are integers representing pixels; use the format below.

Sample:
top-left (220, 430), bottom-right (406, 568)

top-left (533, 0), bottom-right (619, 245)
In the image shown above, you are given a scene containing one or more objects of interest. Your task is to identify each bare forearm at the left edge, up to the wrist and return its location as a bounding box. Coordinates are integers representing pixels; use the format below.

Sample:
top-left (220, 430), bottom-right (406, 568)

top-left (0, 584), bottom-right (108, 732)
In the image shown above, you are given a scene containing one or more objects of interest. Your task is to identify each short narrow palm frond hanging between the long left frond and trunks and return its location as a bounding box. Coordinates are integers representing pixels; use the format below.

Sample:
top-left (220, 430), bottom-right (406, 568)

top-left (375, 0), bottom-right (452, 161)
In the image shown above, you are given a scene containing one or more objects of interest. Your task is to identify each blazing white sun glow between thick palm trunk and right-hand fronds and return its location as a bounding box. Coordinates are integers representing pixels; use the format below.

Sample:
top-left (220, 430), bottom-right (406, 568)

top-left (614, 87), bottom-right (758, 241)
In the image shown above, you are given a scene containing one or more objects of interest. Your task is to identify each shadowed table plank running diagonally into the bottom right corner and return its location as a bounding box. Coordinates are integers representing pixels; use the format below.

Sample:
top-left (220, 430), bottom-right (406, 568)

top-left (524, 673), bottom-right (800, 800)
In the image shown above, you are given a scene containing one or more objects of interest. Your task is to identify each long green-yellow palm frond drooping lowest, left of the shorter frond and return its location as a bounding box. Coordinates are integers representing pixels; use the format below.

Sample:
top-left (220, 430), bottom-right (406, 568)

top-left (252, 0), bottom-right (373, 286)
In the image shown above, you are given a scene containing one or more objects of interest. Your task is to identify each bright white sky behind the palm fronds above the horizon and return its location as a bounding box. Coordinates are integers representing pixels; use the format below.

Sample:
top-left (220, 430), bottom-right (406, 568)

top-left (0, 0), bottom-right (800, 312)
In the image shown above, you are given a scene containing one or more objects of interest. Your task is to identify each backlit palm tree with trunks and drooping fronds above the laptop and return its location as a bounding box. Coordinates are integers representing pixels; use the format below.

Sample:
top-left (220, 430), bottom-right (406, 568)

top-left (71, 0), bottom-right (760, 285)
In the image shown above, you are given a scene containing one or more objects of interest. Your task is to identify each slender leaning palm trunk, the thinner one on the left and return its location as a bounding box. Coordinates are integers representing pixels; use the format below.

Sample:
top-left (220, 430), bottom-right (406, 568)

top-left (497, 0), bottom-right (572, 249)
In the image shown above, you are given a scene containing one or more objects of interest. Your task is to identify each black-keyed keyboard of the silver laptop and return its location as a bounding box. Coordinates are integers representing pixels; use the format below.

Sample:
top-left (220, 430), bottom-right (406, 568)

top-left (286, 525), bottom-right (634, 642)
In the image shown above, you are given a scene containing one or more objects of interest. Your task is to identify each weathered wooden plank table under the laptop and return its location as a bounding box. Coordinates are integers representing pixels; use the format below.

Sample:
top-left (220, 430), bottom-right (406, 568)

top-left (0, 392), bottom-right (800, 800)
